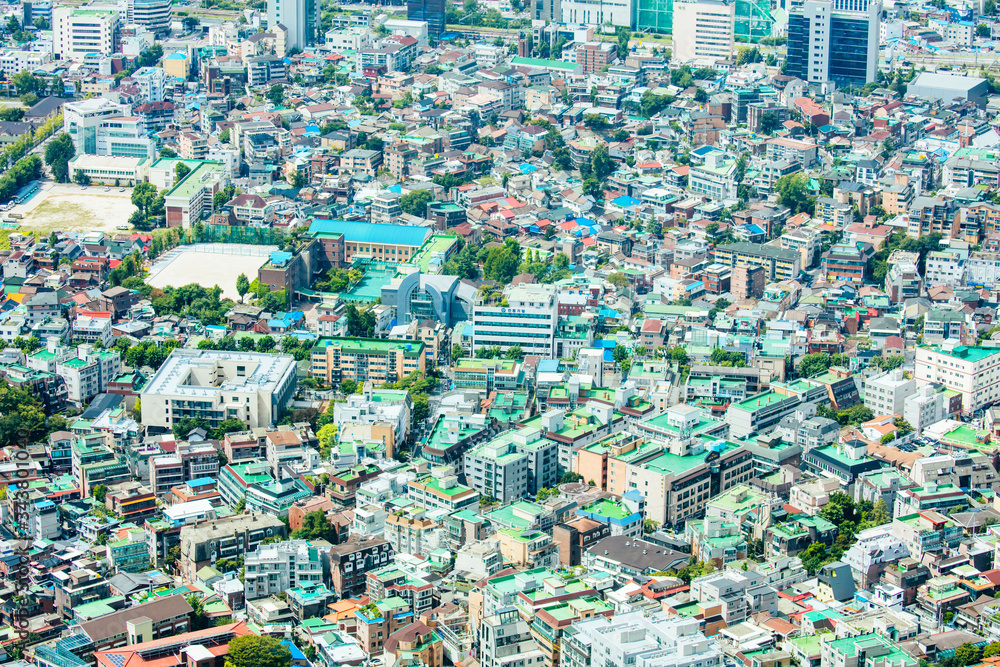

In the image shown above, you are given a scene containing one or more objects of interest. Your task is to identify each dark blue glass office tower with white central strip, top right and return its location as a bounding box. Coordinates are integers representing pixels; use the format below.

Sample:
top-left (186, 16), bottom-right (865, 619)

top-left (786, 0), bottom-right (882, 86)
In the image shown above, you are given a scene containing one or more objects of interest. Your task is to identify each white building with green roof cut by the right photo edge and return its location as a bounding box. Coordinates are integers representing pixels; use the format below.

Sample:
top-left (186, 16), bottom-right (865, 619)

top-left (914, 345), bottom-right (1000, 415)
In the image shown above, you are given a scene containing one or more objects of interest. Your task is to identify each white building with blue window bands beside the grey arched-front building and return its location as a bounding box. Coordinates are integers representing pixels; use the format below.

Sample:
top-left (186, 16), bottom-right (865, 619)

top-left (472, 285), bottom-right (559, 359)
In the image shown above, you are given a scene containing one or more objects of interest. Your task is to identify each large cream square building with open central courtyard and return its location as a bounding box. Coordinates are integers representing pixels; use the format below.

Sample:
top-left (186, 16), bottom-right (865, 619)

top-left (141, 348), bottom-right (296, 428)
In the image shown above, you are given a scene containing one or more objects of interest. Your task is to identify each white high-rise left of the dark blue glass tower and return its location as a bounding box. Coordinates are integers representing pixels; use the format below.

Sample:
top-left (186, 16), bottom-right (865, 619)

top-left (673, 0), bottom-right (736, 63)
